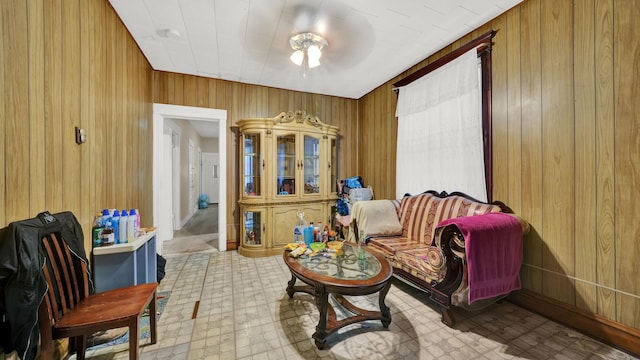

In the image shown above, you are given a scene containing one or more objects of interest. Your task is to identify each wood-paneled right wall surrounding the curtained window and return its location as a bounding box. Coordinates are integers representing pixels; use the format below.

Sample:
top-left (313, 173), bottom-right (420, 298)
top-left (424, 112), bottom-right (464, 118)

top-left (358, 0), bottom-right (640, 329)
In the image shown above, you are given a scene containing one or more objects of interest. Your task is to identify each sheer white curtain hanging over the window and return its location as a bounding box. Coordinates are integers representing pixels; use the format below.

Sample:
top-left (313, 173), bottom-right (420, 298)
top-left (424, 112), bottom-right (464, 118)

top-left (396, 49), bottom-right (487, 201)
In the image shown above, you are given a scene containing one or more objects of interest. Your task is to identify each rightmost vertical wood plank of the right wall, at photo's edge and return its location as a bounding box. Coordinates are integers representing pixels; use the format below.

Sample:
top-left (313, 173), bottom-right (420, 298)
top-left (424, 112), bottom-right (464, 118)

top-left (612, 0), bottom-right (640, 328)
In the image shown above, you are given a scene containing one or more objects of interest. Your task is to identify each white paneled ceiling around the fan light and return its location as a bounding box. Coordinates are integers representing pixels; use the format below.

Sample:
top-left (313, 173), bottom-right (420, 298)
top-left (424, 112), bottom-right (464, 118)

top-left (109, 0), bottom-right (522, 99)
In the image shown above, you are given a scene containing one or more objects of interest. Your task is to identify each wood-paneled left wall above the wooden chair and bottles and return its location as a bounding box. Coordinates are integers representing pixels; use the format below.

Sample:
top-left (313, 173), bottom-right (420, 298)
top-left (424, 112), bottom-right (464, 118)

top-left (0, 0), bottom-right (153, 249)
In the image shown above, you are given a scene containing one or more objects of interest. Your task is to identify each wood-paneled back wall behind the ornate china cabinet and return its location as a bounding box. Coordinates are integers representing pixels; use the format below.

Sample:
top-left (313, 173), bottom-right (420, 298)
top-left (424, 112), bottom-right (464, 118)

top-left (153, 71), bottom-right (358, 249)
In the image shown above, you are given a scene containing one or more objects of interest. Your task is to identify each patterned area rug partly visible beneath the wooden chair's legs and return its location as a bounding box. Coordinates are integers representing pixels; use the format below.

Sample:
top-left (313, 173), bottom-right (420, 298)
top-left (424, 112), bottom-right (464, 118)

top-left (87, 291), bottom-right (171, 350)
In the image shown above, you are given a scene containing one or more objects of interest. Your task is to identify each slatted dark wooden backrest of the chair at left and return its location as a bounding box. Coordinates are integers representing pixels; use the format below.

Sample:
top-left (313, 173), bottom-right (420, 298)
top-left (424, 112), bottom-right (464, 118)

top-left (41, 233), bottom-right (89, 326)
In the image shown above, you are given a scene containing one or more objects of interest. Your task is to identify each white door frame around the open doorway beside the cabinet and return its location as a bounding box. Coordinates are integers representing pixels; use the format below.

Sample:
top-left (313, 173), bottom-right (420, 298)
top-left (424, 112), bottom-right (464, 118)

top-left (153, 103), bottom-right (227, 251)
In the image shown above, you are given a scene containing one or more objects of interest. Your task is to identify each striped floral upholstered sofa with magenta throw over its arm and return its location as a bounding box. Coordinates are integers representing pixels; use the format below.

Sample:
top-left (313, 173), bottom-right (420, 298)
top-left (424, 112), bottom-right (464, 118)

top-left (349, 191), bottom-right (529, 326)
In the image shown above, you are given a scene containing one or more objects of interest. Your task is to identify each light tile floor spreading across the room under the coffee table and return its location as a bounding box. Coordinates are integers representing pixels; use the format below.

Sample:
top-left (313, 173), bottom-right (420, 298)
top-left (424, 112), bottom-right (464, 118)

top-left (82, 251), bottom-right (637, 360)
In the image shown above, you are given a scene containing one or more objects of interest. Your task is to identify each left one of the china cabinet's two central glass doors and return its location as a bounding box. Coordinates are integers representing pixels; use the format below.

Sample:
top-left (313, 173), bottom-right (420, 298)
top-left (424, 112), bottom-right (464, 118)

top-left (275, 134), bottom-right (297, 196)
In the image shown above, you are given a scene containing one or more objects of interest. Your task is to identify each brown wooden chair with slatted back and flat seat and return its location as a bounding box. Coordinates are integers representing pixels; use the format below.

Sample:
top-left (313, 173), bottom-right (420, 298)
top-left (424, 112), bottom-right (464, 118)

top-left (38, 233), bottom-right (158, 360)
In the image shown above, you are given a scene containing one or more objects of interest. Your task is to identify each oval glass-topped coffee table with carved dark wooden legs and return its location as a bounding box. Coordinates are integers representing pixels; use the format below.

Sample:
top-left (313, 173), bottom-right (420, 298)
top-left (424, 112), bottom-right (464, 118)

top-left (283, 243), bottom-right (392, 349)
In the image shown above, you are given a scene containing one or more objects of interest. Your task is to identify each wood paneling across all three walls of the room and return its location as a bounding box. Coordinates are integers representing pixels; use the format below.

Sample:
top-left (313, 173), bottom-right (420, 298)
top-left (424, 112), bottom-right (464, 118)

top-left (5, 0), bottom-right (640, 338)
